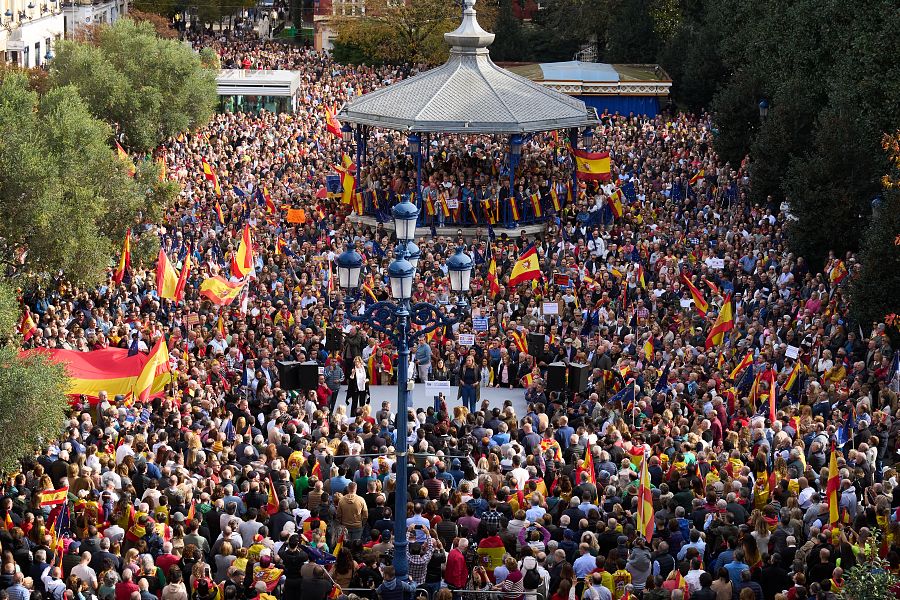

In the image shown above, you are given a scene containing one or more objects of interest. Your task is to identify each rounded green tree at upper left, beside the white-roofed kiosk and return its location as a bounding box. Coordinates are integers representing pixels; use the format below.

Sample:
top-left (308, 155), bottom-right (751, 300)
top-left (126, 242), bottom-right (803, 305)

top-left (51, 19), bottom-right (217, 151)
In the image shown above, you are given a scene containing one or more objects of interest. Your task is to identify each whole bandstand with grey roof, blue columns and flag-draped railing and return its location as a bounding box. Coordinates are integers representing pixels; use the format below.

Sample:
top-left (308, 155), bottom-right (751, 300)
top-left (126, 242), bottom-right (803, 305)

top-left (338, 0), bottom-right (598, 236)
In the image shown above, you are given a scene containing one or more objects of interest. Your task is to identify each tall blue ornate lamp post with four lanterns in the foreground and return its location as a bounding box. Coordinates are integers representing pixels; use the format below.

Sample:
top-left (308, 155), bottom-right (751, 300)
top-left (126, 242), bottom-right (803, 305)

top-left (335, 200), bottom-right (473, 580)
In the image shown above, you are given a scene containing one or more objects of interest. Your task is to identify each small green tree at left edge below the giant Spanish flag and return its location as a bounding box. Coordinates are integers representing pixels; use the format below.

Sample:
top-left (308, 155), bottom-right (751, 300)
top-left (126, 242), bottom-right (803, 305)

top-left (0, 343), bottom-right (68, 474)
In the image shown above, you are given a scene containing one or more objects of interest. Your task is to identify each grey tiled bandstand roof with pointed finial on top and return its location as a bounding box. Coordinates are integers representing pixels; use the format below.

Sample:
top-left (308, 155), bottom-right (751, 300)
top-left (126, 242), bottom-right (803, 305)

top-left (338, 0), bottom-right (598, 134)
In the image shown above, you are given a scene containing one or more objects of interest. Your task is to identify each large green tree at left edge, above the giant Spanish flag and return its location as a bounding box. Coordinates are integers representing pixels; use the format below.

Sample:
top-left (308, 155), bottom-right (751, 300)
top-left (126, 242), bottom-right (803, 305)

top-left (0, 74), bottom-right (176, 283)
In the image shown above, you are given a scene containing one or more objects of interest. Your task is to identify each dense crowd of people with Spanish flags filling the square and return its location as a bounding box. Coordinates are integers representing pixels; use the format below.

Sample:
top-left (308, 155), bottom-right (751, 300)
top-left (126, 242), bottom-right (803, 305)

top-left (0, 30), bottom-right (900, 600)
